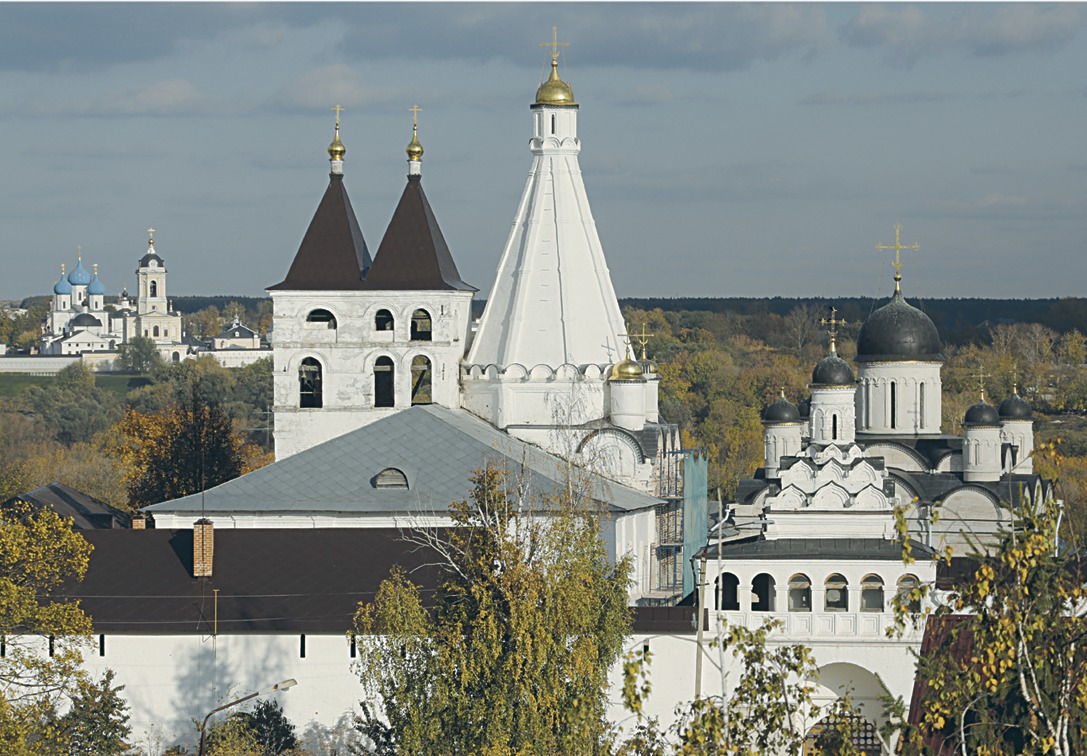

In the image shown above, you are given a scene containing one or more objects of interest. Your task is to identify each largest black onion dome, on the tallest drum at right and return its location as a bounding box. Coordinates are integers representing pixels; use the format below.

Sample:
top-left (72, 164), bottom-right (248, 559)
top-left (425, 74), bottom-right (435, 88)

top-left (857, 292), bottom-right (944, 362)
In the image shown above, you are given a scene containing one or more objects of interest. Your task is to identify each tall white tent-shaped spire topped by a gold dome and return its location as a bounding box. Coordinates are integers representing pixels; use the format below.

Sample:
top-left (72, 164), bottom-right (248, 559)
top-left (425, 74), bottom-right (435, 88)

top-left (467, 59), bottom-right (625, 369)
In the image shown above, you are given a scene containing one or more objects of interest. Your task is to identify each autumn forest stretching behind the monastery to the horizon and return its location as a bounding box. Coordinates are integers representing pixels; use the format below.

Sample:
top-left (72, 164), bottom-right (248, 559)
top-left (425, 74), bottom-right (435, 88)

top-left (0, 297), bottom-right (1087, 537)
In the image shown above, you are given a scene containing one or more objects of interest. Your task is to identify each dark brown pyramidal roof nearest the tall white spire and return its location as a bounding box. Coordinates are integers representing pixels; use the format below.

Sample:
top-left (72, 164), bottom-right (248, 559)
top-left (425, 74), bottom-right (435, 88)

top-left (365, 175), bottom-right (476, 292)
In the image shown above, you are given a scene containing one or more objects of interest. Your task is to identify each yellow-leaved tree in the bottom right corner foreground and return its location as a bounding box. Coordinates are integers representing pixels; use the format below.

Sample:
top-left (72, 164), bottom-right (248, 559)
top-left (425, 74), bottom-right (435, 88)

top-left (896, 448), bottom-right (1087, 756)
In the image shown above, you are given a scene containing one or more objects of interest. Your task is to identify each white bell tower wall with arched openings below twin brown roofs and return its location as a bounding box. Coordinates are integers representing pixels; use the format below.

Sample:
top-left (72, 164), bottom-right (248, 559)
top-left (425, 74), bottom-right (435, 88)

top-left (272, 289), bottom-right (472, 459)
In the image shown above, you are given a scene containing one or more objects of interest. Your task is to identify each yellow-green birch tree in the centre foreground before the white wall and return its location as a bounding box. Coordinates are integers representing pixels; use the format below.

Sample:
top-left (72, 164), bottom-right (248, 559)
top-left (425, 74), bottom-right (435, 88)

top-left (354, 467), bottom-right (630, 756)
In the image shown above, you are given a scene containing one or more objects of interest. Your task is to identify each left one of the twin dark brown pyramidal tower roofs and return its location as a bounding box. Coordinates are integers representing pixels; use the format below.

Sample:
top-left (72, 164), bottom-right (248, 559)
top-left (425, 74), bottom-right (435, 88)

top-left (268, 173), bottom-right (371, 290)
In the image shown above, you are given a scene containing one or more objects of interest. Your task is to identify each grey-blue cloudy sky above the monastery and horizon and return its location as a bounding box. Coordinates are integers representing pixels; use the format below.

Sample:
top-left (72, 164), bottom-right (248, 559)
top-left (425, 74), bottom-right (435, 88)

top-left (0, 2), bottom-right (1087, 299)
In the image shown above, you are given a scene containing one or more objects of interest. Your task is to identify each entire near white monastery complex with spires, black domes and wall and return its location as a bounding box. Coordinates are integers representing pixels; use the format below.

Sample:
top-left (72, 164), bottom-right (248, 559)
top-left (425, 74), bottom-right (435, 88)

top-left (44, 39), bottom-right (1052, 753)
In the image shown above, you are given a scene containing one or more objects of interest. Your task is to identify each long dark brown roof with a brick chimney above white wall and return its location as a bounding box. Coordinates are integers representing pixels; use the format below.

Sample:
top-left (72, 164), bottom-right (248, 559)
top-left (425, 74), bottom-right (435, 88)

top-left (66, 528), bottom-right (438, 634)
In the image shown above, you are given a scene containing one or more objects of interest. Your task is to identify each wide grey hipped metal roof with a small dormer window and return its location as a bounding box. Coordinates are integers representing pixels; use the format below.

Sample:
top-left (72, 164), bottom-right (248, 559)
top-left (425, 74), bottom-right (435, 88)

top-left (146, 405), bottom-right (660, 515)
